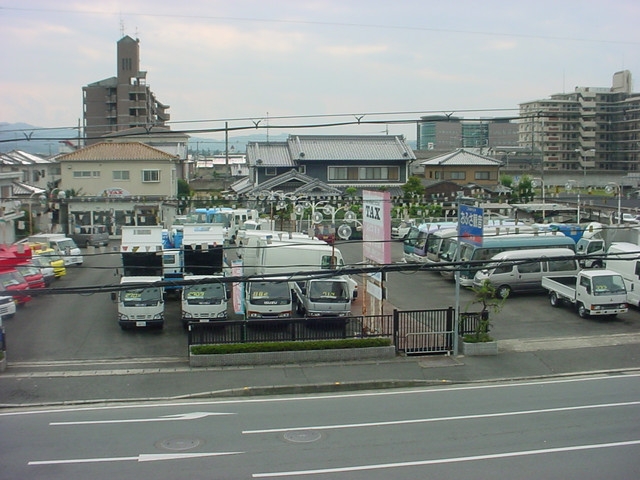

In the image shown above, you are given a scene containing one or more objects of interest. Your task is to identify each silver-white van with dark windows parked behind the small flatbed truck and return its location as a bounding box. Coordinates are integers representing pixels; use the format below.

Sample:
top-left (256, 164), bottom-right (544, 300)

top-left (473, 248), bottom-right (580, 298)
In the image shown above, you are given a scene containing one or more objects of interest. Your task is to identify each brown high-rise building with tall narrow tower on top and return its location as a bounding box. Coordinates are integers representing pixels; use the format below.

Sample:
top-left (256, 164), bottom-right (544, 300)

top-left (82, 35), bottom-right (169, 145)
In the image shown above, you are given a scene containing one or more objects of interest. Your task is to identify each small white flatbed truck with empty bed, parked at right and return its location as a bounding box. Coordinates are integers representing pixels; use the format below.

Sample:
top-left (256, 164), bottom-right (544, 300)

top-left (542, 269), bottom-right (628, 318)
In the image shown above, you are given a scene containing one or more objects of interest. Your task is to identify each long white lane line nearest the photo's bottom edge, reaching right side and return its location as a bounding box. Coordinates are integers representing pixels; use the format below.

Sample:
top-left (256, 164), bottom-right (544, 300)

top-left (252, 440), bottom-right (640, 478)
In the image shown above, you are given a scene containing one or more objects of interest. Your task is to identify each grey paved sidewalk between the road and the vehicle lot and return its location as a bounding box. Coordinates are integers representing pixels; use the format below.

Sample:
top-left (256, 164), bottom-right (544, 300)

top-left (0, 334), bottom-right (640, 408)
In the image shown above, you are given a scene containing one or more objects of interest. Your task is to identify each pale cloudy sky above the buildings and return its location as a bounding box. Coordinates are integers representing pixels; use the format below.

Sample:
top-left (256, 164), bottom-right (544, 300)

top-left (0, 0), bottom-right (640, 148)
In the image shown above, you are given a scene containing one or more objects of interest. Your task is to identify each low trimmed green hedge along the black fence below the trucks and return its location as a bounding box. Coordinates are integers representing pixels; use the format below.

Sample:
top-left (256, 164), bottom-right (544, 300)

top-left (191, 338), bottom-right (391, 355)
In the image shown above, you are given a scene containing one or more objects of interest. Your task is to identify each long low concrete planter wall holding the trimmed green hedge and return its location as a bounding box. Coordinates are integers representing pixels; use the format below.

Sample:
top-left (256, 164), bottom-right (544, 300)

top-left (189, 345), bottom-right (396, 367)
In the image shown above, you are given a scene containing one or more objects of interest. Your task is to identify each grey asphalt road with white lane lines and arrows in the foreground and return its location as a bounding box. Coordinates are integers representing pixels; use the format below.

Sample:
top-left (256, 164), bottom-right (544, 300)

top-left (0, 375), bottom-right (640, 480)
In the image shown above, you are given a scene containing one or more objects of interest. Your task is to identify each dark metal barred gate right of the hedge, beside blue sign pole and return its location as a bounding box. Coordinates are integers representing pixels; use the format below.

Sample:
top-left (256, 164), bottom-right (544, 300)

top-left (393, 307), bottom-right (455, 355)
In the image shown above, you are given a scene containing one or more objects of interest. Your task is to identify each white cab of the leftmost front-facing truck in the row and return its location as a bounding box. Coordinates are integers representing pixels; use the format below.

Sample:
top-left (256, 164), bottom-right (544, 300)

top-left (111, 276), bottom-right (164, 330)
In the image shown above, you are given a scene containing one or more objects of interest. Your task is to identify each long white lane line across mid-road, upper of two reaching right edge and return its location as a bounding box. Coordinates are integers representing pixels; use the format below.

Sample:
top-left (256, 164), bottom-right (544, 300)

top-left (242, 401), bottom-right (640, 434)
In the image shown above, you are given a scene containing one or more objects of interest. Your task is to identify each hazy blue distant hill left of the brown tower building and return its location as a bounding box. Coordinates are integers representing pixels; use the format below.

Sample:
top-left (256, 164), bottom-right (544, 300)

top-left (0, 122), bottom-right (78, 157)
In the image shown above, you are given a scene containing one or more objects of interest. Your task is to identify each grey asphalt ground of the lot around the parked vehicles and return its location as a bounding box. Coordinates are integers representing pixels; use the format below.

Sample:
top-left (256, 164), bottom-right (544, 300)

top-left (4, 242), bottom-right (640, 364)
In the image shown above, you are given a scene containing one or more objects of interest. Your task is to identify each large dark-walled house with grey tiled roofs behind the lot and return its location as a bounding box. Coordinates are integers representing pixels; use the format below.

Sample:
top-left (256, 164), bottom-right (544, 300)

top-left (239, 135), bottom-right (415, 198)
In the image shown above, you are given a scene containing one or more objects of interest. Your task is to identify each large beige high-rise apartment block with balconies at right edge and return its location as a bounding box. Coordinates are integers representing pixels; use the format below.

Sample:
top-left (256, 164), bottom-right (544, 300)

top-left (518, 70), bottom-right (640, 173)
